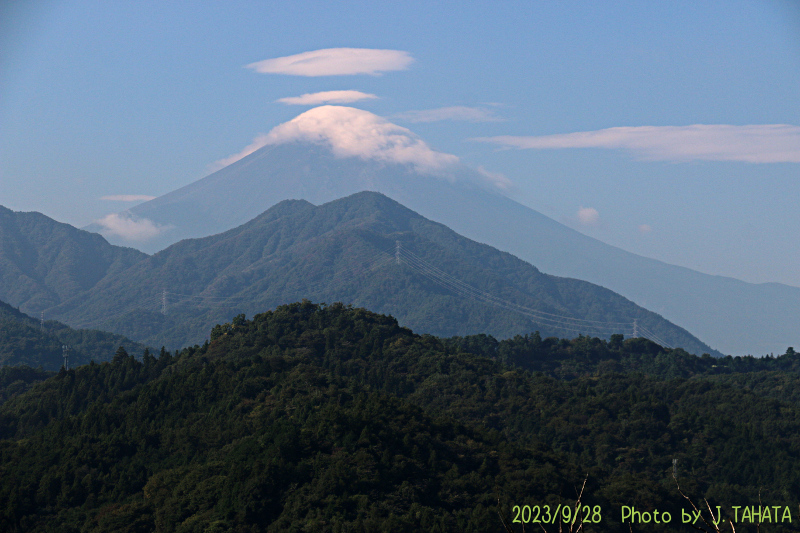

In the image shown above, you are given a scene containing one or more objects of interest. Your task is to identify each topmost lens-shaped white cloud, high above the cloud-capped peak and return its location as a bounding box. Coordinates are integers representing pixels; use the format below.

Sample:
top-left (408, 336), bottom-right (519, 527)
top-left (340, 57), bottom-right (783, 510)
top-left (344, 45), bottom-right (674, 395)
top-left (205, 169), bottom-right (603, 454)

top-left (246, 48), bottom-right (414, 76)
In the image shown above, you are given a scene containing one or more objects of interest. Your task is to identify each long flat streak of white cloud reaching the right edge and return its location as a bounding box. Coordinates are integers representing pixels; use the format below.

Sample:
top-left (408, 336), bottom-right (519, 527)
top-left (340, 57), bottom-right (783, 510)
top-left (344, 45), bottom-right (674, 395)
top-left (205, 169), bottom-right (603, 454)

top-left (474, 124), bottom-right (800, 163)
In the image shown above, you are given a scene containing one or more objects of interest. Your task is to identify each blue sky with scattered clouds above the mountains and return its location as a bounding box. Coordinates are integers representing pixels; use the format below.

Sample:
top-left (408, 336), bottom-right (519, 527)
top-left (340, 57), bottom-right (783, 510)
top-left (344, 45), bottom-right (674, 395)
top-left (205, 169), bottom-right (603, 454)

top-left (0, 0), bottom-right (800, 286)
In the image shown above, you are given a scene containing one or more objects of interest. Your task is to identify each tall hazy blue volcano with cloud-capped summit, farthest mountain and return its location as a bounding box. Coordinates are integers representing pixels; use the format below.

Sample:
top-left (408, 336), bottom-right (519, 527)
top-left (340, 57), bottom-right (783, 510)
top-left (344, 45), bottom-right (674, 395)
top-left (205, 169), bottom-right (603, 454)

top-left (87, 106), bottom-right (800, 355)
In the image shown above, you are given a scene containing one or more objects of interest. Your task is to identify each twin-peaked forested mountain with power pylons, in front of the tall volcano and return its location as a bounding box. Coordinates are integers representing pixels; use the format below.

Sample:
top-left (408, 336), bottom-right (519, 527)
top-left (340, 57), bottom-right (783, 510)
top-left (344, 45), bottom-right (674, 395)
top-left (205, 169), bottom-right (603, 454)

top-left (0, 192), bottom-right (719, 355)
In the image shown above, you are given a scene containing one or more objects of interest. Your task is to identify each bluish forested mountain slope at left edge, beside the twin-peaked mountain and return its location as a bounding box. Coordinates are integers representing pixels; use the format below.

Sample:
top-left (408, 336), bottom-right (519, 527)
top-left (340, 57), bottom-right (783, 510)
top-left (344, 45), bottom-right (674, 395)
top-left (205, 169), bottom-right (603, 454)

top-left (0, 206), bottom-right (147, 312)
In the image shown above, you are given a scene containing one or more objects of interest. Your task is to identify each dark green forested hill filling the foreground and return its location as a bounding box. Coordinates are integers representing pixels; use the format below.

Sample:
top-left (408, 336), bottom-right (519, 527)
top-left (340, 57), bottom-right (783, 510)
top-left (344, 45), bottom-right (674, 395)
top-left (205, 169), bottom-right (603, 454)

top-left (0, 302), bottom-right (800, 532)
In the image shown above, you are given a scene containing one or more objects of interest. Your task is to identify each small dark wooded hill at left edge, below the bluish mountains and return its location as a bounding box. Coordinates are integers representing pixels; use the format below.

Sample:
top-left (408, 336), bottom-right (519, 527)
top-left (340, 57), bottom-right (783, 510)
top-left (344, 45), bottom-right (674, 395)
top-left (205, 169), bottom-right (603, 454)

top-left (0, 301), bottom-right (144, 371)
